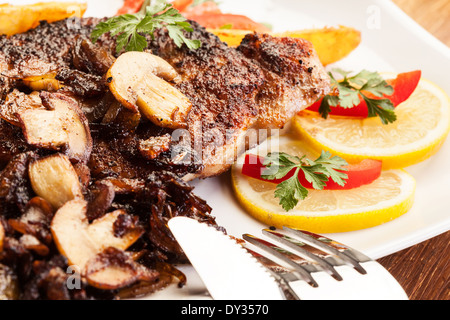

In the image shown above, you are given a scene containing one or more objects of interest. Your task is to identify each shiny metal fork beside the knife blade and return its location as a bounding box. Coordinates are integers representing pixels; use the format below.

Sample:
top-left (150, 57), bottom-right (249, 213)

top-left (242, 227), bottom-right (408, 300)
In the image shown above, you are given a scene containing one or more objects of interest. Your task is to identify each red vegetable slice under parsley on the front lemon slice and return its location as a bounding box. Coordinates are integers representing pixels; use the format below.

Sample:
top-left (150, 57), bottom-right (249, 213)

top-left (242, 154), bottom-right (382, 190)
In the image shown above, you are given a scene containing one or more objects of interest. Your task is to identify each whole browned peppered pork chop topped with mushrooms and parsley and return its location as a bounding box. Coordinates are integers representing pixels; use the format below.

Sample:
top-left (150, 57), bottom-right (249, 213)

top-left (0, 18), bottom-right (329, 180)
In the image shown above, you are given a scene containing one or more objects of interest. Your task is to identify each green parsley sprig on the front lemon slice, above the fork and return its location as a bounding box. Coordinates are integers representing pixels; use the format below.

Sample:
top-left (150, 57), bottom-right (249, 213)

top-left (261, 151), bottom-right (348, 211)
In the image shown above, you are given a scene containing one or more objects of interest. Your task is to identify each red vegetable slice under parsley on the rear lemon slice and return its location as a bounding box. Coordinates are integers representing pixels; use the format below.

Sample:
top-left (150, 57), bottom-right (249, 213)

top-left (307, 70), bottom-right (422, 118)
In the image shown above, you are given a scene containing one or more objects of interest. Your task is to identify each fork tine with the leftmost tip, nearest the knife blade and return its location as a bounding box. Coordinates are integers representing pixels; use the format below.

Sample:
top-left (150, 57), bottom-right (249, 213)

top-left (242, 234), bottom-right (320, 287)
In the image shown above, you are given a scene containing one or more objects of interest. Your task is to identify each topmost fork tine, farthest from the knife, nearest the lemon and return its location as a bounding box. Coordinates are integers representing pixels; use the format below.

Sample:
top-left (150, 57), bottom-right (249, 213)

top-left (283, 227), bottom-right (372, 274)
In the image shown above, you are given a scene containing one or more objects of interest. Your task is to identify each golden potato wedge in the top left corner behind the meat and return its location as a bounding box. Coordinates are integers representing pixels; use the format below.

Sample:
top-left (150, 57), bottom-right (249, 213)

top-left (0, 2), bottom-right (87, 36)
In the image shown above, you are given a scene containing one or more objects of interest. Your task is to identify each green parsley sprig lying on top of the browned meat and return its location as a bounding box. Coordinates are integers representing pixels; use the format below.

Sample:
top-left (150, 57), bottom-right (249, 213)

top-left (91, 0), bottom-right (201, 53)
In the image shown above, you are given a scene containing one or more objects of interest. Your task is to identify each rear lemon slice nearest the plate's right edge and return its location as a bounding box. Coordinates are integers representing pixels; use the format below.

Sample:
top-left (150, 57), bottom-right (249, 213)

top-left (293, 80), bottom-right (450, 169)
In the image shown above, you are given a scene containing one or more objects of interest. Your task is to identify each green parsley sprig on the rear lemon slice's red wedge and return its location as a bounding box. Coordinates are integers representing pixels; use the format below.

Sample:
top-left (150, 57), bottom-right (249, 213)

top-left (319, 69), bottom-right (397, 124)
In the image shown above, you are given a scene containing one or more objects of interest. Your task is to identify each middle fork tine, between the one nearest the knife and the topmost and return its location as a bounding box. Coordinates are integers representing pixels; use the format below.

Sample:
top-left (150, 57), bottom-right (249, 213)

top-left (263, 229), bottom-right (343, 281)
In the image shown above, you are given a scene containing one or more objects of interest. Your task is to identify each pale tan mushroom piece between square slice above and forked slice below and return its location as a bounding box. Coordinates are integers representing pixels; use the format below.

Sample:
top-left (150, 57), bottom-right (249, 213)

top-left (28, 153), bottom-right (83, 209)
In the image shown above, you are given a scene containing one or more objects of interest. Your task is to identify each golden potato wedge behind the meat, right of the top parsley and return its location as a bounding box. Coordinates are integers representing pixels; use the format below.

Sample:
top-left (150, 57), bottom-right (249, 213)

top-left (209, 26), bottom-right (361, 66)
